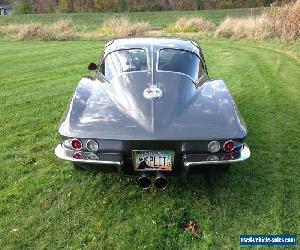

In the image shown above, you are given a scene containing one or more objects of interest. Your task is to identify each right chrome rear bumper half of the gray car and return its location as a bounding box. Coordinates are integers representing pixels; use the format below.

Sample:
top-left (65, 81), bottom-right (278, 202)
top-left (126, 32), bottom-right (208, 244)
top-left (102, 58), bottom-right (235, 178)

top-left (183, 144), bottom-right (251, 168)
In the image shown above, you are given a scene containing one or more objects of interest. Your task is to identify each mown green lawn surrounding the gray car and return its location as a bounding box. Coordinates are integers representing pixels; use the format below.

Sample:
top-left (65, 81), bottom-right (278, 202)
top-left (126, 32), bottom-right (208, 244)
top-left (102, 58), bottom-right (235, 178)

top-left (0, 39), bottom-right (300, 249)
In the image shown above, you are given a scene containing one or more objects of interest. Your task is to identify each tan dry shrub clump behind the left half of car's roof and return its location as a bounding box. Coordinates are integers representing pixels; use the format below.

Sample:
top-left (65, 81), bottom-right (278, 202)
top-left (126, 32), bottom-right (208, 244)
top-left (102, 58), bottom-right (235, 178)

top-left (100, 17), bottom-right (151, 37)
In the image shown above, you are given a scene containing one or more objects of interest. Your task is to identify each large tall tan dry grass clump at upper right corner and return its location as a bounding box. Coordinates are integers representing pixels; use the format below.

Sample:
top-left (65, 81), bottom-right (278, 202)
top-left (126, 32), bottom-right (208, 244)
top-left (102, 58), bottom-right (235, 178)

top-left (215, 0), bottom-right (300, 40)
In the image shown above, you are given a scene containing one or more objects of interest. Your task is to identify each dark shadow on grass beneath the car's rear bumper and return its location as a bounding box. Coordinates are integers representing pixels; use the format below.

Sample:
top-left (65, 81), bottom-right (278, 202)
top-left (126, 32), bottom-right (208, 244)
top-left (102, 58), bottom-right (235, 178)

top-left (74, 165), bottom-right (256, 202)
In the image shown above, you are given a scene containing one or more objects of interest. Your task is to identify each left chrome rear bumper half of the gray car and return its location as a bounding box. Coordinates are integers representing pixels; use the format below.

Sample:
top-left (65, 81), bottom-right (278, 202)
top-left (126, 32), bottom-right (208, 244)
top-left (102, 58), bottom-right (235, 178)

top-left (55, 144), bottom-right (123, 167)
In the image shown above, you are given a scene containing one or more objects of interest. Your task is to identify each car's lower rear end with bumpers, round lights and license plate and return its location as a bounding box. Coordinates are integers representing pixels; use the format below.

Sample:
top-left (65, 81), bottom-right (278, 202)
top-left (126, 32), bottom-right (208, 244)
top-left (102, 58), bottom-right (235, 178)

top-left (55, 138), bottom-right (250, 175)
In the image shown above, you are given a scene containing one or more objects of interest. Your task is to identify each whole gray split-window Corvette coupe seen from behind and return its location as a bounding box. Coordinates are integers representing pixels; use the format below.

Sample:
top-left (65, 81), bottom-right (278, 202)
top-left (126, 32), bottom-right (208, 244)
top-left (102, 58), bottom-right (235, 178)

top-left (55, 38), bottom-right (250, 189)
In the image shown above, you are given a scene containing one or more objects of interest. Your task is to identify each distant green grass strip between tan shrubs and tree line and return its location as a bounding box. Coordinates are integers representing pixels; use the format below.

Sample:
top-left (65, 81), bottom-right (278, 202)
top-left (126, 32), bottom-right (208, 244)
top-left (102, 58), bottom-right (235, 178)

top-left (0, 8), bottom-right (262, 30)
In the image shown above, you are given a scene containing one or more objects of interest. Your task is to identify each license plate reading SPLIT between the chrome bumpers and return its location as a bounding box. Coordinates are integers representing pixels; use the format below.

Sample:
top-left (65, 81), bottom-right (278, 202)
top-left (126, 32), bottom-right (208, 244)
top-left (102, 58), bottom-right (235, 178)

top-left (132, 150), bottom-right (174, 171)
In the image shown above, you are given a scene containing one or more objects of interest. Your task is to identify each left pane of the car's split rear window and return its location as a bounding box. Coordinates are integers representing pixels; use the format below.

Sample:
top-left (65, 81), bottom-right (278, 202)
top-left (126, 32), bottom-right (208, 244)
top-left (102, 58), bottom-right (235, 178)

top-left (101, 49), bottom-right (148, 80)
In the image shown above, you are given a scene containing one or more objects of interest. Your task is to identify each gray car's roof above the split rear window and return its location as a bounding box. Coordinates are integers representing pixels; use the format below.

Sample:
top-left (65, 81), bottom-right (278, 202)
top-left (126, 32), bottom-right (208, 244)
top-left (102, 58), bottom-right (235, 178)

top-left (103, 37), bottom-right (200, 57)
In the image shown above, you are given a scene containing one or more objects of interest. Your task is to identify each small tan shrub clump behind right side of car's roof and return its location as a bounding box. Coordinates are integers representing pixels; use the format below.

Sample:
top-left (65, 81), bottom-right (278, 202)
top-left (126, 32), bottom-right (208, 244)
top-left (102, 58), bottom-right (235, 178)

top-left (166, 17), bottom-right (214, 33)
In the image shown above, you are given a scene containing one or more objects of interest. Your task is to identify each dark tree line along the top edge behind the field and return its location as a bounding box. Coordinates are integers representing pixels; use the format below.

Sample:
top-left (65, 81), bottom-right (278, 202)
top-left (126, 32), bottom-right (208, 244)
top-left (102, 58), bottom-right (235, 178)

top-left (0, 0), bottom-right (286, 13)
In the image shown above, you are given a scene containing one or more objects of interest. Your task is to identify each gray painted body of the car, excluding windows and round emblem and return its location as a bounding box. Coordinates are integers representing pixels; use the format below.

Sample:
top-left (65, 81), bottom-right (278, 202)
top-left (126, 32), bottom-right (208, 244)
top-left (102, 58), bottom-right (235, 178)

top-left (59, 38), bottom-right (247, 140)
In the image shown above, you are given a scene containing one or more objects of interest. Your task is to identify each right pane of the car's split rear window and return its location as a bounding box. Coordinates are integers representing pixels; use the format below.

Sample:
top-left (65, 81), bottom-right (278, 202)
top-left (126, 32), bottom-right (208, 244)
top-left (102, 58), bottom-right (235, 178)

top-left (158, 49), bottom-right (203, 81)
